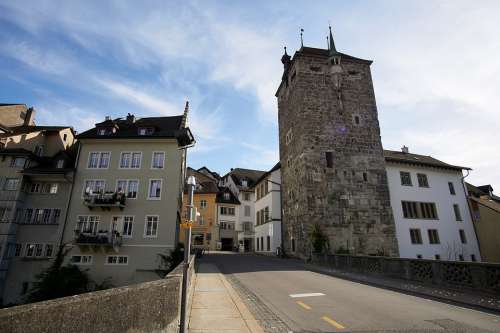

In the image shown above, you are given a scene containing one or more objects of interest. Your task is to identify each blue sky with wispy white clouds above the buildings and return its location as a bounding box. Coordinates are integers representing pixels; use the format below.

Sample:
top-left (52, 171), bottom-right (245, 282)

top-left (0, 0), bottom-right (500, 191)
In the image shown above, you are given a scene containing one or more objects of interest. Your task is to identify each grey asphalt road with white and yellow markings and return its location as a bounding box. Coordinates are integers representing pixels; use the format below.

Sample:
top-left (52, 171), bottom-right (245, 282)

top-left (202, 254), bottom-right (500, 333)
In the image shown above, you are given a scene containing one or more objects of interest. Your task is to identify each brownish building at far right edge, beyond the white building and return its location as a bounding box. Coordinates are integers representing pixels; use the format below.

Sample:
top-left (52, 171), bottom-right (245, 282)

top-left (466, 184), bottom-right (500, 263)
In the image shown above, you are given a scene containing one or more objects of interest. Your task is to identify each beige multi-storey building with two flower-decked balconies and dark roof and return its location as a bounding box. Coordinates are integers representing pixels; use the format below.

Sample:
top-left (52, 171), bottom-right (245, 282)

top-left (64, 111), bottom-right (194, 286)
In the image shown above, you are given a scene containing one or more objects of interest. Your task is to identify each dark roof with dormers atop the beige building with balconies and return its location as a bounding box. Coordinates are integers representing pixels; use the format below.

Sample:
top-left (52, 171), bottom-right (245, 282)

top-left (77, 116), bottom-right (194, 145)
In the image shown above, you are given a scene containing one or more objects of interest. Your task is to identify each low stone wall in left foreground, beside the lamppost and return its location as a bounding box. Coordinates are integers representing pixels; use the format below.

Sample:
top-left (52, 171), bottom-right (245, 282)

top-left (0, 256), bottom-right (195, 333)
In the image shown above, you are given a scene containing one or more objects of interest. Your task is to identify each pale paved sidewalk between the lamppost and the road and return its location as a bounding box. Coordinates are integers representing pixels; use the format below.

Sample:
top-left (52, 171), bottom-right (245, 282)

top-left (188, 263), bottom-right (264, 333)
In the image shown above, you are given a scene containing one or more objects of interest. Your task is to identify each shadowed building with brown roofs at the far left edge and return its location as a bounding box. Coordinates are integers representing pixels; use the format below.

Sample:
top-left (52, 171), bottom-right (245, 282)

top-left (0, 107), bottom-right (75, 304)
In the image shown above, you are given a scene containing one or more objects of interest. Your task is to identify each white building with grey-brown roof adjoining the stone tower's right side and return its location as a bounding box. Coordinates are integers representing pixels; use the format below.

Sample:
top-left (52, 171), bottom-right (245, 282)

top-left (384, 147), bottom-right (481, 261)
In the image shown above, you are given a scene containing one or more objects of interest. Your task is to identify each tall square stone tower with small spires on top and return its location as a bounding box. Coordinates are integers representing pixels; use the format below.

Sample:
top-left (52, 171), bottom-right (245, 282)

top-left (276, 31), bottom-right (398, 257)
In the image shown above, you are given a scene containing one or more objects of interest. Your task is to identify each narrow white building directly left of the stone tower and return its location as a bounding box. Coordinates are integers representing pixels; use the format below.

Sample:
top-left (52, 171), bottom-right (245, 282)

top-left (254, 163), bottom-right (281, 254)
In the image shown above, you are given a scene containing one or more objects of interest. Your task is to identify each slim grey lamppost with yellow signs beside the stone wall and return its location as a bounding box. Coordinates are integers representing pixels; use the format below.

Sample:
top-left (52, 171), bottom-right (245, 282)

top-left (179, 176), bottom-right (196, 333)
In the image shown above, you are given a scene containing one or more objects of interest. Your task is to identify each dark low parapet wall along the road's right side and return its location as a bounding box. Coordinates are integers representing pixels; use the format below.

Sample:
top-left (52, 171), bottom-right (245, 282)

top-left (312, 254), bottom-right (500, 294)
